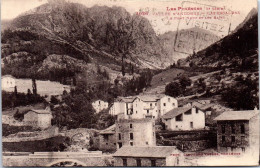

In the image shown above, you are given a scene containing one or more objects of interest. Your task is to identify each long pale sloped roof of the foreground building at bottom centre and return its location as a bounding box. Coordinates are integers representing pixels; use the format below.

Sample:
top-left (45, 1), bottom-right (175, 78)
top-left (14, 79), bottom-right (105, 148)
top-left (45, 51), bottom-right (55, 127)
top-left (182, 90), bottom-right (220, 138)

top-left (113, 146), bottom-right (179, 158)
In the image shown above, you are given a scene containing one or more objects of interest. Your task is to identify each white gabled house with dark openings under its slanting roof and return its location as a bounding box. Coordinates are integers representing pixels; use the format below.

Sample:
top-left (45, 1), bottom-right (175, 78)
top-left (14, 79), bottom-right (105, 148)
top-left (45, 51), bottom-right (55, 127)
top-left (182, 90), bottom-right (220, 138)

top-left (162, 106), bottom-right (205, 130)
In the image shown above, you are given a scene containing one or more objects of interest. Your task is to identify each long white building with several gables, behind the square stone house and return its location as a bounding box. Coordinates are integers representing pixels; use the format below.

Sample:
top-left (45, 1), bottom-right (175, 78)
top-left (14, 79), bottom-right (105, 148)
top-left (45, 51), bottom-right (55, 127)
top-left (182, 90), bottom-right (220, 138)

top-left (110, 95), bottom-right (178, 119)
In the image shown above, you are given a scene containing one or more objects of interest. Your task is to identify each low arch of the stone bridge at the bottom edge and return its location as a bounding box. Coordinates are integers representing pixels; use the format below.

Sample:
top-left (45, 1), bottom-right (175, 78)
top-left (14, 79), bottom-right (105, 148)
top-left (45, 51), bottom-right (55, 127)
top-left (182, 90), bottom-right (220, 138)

top-left (46, 159), bottom-right (87, 167)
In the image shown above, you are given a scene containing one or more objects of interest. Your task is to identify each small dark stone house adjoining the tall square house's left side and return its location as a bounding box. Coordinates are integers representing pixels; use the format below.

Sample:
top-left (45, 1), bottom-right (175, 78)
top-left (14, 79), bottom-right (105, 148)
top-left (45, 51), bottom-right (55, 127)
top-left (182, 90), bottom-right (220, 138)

top-left (99, 124), bottom-right (116, 151)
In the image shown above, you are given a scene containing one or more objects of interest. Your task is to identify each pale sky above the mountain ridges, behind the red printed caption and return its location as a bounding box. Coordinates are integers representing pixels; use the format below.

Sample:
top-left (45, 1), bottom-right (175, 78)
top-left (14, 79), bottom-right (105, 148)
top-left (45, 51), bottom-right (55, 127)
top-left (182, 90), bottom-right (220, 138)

top-left (1, 0), bottom-right (257, 34)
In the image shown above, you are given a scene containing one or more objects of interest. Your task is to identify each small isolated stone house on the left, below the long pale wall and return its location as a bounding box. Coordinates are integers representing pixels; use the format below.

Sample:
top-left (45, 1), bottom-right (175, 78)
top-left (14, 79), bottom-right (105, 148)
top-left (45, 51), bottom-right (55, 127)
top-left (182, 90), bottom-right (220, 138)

top-left (23, 108), bottom-right (52, 129)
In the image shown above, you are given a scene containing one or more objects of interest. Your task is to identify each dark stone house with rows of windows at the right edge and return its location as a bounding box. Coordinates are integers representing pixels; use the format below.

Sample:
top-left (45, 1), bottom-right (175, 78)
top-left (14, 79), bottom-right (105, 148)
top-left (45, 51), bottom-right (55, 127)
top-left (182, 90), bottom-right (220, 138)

top-left (215, 110), bottom-right (259, 156)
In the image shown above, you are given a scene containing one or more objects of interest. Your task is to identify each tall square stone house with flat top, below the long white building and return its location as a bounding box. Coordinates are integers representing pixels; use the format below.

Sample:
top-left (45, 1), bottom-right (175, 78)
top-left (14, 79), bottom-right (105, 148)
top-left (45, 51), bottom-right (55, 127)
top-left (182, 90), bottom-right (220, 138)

top-left (116, 118), bottom-right (156, 149)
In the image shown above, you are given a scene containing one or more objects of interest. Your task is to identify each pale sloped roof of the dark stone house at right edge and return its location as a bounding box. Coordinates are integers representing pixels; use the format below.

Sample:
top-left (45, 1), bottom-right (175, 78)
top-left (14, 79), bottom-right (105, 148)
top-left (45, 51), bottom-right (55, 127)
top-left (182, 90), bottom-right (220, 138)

top-left (214, 110), bottom-right (259, 121)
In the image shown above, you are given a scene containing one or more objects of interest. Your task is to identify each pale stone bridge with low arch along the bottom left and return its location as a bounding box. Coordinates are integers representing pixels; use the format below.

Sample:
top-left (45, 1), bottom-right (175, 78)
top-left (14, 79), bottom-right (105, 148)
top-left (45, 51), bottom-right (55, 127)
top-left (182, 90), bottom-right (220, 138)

top-left (3, 151), bottom-right (105, 167)
